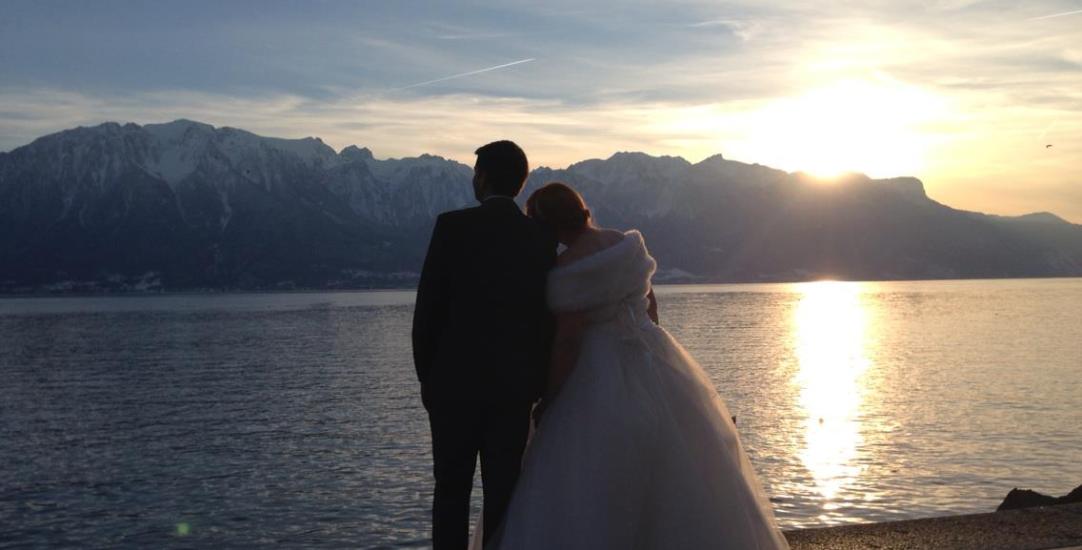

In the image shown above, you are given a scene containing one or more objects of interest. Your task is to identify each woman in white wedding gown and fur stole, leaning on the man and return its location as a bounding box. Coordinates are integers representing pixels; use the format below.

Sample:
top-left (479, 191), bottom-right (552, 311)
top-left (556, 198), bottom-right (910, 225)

top-left (488, 183), bottom-right (788, 550)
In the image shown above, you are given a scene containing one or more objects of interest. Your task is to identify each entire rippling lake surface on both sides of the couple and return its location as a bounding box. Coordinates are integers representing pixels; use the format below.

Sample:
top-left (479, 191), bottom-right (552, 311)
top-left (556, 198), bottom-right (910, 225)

top-left (0, 279), bottom-right (1082, 548)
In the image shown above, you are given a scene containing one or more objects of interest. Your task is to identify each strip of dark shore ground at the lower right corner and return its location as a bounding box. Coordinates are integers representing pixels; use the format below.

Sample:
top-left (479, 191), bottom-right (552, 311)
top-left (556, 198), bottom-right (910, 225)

top-left (786, 503), bottom-right (1082, 550)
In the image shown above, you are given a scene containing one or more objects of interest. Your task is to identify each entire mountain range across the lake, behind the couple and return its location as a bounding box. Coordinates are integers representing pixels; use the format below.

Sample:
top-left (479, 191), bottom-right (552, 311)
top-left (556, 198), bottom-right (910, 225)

top-left (0, 120), bottom-right (1082, 292)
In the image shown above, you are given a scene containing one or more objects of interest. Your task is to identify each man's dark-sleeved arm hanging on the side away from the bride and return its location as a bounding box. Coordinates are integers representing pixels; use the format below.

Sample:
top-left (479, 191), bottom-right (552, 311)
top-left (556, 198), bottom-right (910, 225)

top-left (412, 214), bottom-right (450, 405)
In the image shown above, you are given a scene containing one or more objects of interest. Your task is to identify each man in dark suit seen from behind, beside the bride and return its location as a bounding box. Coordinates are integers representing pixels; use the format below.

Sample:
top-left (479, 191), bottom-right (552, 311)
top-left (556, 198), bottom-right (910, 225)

top-left (413, 141), bottom-right (556, 550)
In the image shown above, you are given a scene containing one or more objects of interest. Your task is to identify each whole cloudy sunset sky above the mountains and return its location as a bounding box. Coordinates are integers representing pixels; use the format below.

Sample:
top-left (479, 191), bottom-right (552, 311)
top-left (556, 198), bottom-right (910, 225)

top-left (0, 0), bottom-right (1082, 223)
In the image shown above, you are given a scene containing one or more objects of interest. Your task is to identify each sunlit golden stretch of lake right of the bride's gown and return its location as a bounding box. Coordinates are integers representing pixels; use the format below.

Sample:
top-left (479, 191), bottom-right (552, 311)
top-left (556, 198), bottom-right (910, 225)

top-left (658, 279), bottom-right (1082, 528)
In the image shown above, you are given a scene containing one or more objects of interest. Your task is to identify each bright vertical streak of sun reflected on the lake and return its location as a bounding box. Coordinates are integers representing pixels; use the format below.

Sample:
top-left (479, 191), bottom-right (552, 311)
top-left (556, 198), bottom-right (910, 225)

top-left (793, 281), bottom-right (869, 511)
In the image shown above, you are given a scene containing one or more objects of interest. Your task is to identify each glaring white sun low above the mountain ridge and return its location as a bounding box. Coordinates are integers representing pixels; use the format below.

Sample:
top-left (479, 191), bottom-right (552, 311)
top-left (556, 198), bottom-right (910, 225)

top-left (751, 78), bottom-right (944, 178)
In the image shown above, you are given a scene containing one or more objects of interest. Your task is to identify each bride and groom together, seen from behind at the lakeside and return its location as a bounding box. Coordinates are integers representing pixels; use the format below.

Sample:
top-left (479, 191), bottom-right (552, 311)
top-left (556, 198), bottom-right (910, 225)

top-left (413, 141), bottom-right (788, 550)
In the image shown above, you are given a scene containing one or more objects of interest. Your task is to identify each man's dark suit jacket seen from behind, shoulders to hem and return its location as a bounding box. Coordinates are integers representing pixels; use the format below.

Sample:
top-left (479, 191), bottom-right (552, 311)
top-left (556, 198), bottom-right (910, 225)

top-left (413, 197), bottom-right (556, 410)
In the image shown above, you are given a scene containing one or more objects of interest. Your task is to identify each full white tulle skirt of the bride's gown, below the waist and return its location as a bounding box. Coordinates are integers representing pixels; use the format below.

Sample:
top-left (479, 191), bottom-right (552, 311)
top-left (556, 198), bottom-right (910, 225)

top-left (488, 316), bottom-right (788, 550)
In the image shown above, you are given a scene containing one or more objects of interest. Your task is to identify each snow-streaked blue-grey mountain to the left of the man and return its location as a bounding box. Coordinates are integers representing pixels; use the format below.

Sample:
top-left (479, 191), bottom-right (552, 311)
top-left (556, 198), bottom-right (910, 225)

top-left (0, 120), bottom-right (472, 288)
